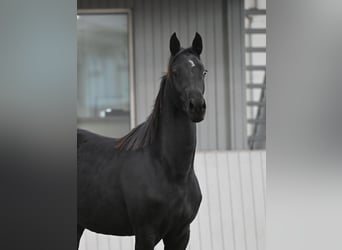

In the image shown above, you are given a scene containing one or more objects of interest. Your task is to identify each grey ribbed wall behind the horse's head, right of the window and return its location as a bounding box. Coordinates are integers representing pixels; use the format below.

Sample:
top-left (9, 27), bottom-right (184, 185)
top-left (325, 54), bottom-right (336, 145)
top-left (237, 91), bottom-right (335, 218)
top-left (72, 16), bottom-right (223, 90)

top-left (78, 0), bottom-right (229, 149)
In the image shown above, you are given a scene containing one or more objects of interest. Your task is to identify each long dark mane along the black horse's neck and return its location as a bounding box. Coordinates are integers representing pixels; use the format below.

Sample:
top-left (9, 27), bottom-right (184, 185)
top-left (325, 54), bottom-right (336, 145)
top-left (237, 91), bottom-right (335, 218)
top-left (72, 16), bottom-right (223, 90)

top-left (115, 76), bottom-right (167, 151)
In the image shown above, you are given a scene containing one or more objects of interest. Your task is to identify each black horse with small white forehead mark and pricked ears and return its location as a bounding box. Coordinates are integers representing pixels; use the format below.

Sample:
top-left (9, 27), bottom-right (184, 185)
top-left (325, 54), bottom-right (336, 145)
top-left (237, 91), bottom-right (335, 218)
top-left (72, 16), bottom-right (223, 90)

top-left (77, 33), bottom-right (207, 250)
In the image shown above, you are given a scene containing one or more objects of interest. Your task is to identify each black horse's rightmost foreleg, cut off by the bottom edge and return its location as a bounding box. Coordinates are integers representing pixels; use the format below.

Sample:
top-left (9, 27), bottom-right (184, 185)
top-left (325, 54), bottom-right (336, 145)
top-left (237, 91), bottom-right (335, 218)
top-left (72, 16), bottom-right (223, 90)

top-left (163, 226), bottom-right (190, 250)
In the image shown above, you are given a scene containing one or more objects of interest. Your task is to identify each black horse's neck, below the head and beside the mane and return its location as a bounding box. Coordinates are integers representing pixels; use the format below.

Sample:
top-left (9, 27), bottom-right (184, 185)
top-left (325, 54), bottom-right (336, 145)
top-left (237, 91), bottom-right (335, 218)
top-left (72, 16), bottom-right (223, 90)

top-left (160, 85), bottom-right (196, 180)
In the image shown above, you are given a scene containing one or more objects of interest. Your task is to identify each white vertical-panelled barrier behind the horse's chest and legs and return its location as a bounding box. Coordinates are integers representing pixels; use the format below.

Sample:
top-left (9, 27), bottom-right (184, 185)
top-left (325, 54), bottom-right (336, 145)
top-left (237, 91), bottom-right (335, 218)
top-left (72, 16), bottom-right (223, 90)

top-left (80, 151), bottom-right (266, 250)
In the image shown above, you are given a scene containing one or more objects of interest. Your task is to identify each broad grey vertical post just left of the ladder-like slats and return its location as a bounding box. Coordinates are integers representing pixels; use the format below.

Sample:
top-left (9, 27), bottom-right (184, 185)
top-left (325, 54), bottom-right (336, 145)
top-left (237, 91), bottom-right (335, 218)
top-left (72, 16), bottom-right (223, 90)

top-left (225, 0), bottom-right (248, 150)
